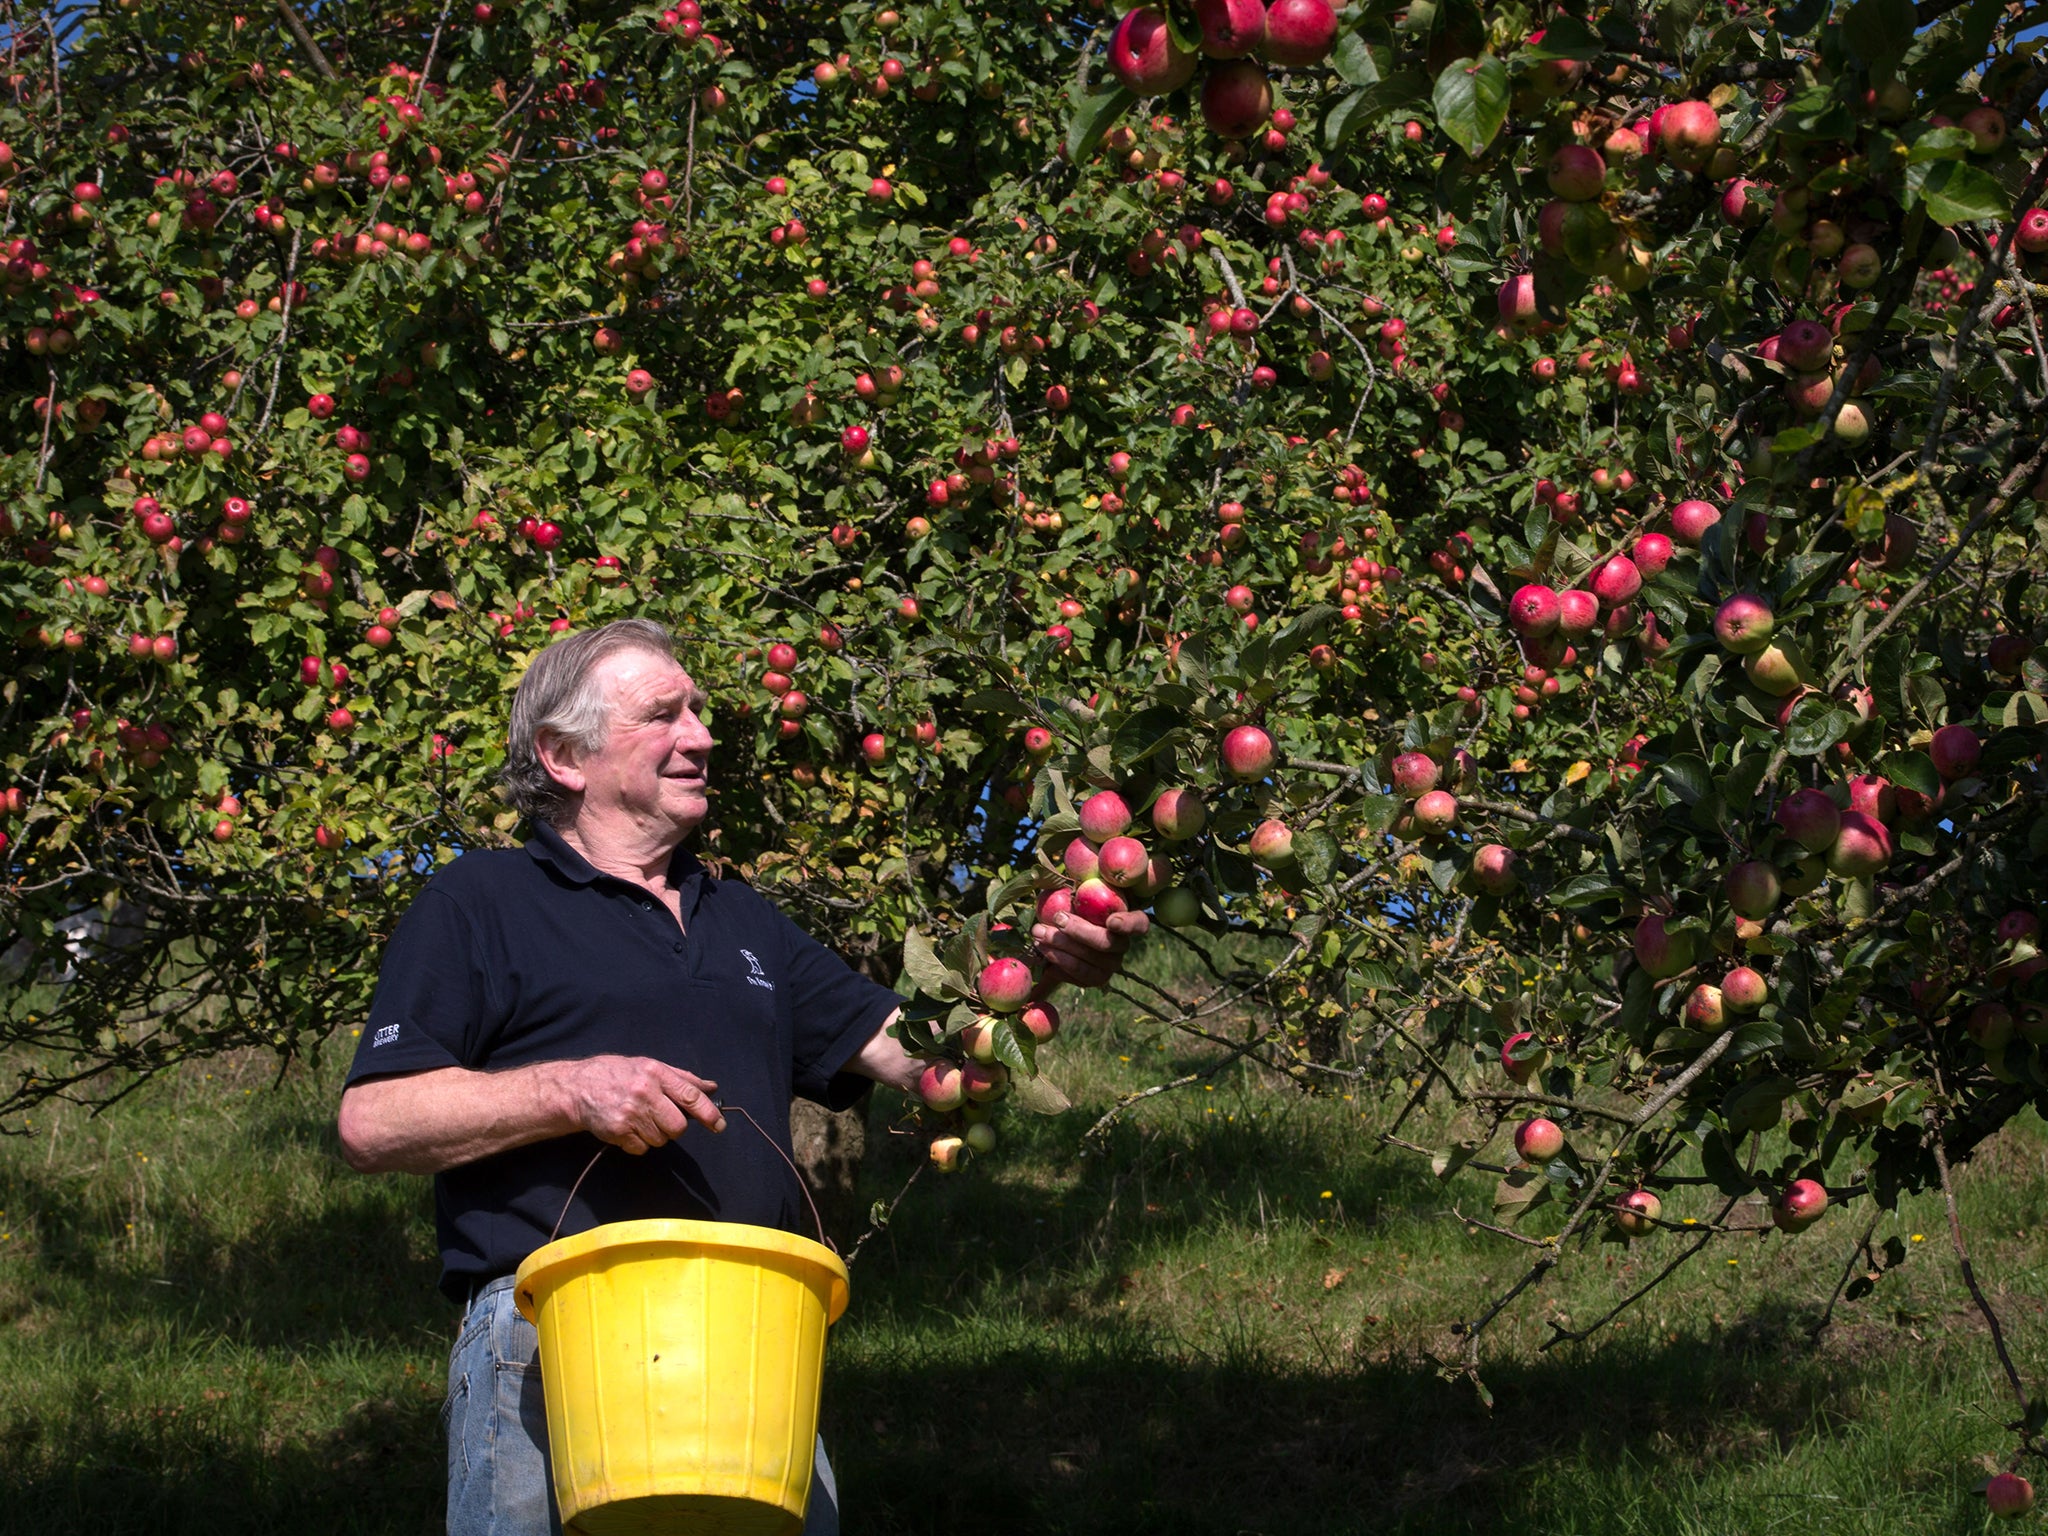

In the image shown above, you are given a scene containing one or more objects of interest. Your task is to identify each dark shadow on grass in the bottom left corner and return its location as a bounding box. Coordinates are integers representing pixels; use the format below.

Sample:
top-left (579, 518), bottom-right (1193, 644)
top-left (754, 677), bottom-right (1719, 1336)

top-left (0, 1393), bottom-right (446, 1536)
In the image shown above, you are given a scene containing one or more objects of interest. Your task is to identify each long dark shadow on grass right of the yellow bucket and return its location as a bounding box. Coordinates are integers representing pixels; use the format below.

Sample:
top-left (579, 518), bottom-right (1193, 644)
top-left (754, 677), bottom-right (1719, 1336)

top-left (825, 1329), bottom-right (1985, 1536)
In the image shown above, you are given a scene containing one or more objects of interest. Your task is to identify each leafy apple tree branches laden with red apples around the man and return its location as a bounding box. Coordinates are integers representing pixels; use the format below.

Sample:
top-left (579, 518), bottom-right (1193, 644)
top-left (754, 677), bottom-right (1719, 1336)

top-left (0, 0), bottom-right (2048, 1497)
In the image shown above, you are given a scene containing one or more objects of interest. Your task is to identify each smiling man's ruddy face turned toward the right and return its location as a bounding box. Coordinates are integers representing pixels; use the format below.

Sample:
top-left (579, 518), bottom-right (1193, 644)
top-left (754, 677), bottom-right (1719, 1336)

top-left (578, 651), bottom-right (711, 840)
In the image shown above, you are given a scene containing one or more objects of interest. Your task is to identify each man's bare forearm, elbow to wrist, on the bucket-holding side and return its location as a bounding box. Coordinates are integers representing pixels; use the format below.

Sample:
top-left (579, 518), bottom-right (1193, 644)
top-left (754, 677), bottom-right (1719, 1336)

top-left (340, 1061), bottom-right (580, 1174)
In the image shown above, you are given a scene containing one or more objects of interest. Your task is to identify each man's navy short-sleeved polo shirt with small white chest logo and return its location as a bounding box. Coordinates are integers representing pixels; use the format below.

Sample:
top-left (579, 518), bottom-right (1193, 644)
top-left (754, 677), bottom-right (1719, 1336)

top-left (348, 823), bottom-right (903, 1300)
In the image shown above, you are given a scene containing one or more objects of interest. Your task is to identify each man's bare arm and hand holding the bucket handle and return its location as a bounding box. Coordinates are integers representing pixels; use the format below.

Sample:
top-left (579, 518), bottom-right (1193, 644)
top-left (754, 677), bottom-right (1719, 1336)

top-left (340, 1057), bottom-right (725, 1174)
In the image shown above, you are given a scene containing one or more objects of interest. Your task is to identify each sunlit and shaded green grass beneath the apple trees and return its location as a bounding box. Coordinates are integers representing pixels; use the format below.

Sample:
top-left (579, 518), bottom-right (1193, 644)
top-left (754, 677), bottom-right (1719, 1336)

top-left (0, 946), bottom-right (2048, 1536)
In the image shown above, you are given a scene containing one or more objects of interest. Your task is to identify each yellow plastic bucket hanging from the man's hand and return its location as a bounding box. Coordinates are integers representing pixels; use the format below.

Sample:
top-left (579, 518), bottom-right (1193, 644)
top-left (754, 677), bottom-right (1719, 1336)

top-left (514, 1221), bottom-right (848, 1536)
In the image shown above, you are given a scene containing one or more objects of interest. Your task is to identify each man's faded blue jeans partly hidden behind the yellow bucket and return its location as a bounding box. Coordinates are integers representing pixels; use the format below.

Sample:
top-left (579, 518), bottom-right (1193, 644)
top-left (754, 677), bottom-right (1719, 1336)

top-left (442, 1276), bottom-right (840, 1536)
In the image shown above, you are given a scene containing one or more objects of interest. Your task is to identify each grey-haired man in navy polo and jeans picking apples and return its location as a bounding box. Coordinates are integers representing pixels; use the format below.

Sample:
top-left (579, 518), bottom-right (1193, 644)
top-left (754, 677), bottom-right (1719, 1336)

top-left (340, 618), bottom-right (1145, 1536)
